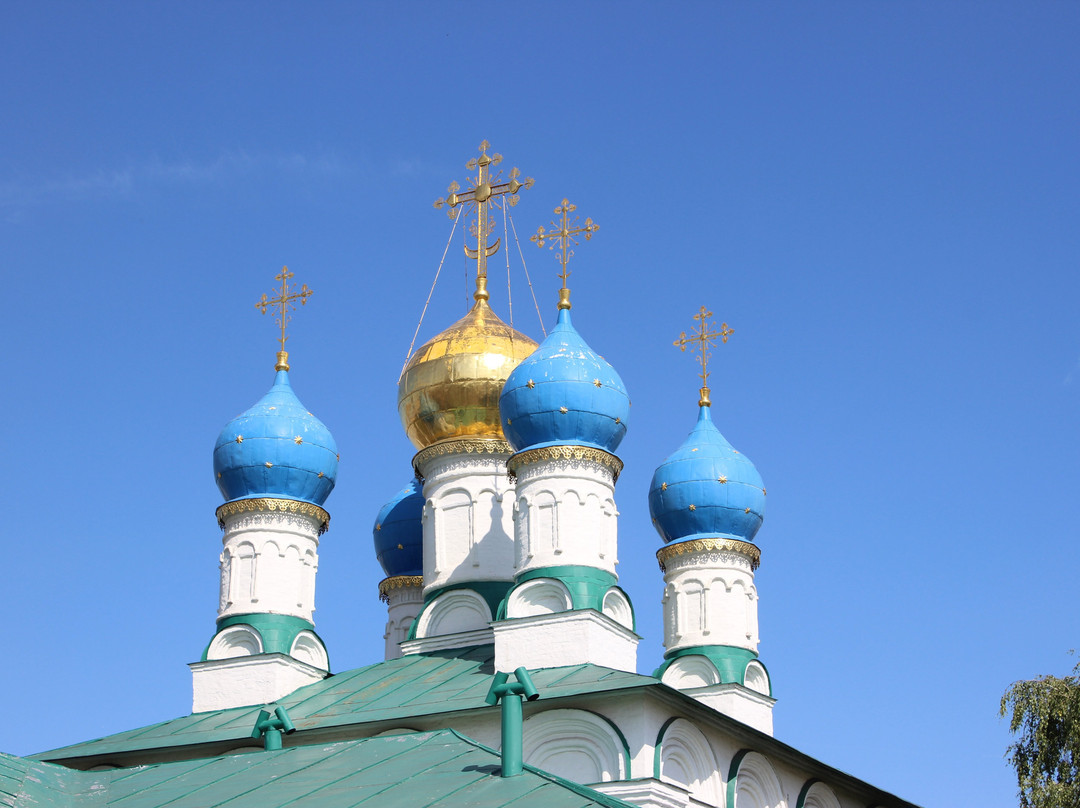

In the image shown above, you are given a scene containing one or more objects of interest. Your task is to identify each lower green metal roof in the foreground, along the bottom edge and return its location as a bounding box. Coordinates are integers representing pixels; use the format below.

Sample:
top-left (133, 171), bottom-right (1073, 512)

top-left (6, 730), bottom-right (631, 808)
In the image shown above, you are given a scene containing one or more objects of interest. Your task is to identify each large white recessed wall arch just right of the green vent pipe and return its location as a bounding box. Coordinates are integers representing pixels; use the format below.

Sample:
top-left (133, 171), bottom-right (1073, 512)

top-left (524, 710), bottom-right (627, 784)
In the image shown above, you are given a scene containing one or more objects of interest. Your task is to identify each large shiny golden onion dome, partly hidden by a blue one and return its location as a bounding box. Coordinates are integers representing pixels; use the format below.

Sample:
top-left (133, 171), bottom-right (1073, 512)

top-left (397, 278), bottom-right (537, 449)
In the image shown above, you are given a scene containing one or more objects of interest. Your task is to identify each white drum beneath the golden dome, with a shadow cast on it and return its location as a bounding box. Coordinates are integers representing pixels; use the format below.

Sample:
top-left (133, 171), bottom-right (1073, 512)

top-left (420, 453), bottom-right (514, 595)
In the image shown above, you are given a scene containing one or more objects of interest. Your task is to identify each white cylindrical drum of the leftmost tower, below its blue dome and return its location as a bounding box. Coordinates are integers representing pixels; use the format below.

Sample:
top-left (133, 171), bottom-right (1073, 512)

top-left (217, 511), bottom-right (320, 621)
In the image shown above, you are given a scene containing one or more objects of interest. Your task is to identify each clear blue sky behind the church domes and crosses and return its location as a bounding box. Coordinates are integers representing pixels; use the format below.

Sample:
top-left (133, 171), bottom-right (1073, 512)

top-left (0, 2), bottom-right (1080, 807)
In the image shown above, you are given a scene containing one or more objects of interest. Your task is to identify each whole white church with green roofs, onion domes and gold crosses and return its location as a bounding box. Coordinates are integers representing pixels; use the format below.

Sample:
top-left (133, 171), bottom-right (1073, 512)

top-left (0, 142), bottom-right (910, 808)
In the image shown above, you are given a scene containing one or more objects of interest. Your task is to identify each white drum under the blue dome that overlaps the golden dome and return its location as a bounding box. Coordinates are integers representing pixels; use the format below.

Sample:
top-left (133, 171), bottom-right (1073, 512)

top-left (514, 459), bottom-right (619, 575)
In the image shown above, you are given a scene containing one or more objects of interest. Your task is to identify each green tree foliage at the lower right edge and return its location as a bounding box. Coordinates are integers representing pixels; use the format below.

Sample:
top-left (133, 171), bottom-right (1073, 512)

top-left (1001, 663), bottom-right (1080, 808)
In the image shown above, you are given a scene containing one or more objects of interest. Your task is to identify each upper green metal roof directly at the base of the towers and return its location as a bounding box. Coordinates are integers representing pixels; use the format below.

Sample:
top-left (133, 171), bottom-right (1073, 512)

top-left (33, 645), bottom-right (660, 764)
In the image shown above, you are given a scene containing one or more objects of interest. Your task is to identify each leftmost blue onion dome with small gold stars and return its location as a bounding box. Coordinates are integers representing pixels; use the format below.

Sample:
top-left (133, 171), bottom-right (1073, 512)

top-left (214, 368), bottom-right (338, 506)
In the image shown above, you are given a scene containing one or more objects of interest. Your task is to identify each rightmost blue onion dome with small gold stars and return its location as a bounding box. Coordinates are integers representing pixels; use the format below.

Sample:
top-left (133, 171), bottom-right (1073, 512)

top-left (649, 404), bottom-right (765, 542)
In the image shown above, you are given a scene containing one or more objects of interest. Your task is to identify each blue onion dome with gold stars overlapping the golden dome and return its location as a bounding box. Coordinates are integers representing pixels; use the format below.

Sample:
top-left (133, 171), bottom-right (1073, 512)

top-left (499, 309), bottom-right (630, 452)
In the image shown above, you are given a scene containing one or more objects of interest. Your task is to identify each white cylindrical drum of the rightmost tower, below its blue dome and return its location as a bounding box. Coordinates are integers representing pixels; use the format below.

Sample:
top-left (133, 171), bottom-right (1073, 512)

top-left (663, 542), bottom-right (758, 652)
